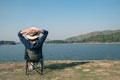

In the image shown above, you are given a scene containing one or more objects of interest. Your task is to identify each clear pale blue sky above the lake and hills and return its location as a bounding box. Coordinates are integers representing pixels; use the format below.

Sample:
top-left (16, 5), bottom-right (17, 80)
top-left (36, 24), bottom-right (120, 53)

top-left (0, 0), bottom-right (120, 41)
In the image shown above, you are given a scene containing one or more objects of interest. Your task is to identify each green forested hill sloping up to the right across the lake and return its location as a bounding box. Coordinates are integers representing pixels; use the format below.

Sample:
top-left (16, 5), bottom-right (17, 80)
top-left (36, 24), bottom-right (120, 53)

top-left (65, 30), bottom-right (120, 43)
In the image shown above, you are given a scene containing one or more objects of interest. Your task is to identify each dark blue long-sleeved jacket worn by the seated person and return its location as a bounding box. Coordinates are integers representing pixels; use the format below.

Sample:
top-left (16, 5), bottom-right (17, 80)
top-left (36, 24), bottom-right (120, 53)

top-left (18, 30), bottom-right (48, 59)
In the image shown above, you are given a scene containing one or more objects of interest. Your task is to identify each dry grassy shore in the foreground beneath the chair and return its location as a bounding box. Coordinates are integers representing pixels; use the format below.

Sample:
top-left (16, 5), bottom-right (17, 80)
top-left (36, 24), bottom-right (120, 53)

top-left (0, 60), bottom-right (120, 80)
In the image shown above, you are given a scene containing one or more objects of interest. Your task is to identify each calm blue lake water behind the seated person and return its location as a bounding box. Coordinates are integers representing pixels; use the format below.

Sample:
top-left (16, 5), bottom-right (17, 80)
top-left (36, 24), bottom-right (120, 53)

top-left (0, 44), bottom-right (120, 62)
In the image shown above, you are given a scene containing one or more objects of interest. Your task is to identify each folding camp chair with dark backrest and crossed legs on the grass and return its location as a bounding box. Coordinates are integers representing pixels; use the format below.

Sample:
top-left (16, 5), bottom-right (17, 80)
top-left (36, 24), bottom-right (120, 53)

top-left (26, 50), bottom-right (43, 75)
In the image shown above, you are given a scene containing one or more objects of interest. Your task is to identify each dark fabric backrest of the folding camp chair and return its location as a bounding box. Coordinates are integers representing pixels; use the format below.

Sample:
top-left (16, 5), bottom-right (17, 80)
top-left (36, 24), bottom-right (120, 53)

top-left (26, 49), bottom-right (40, 62)
